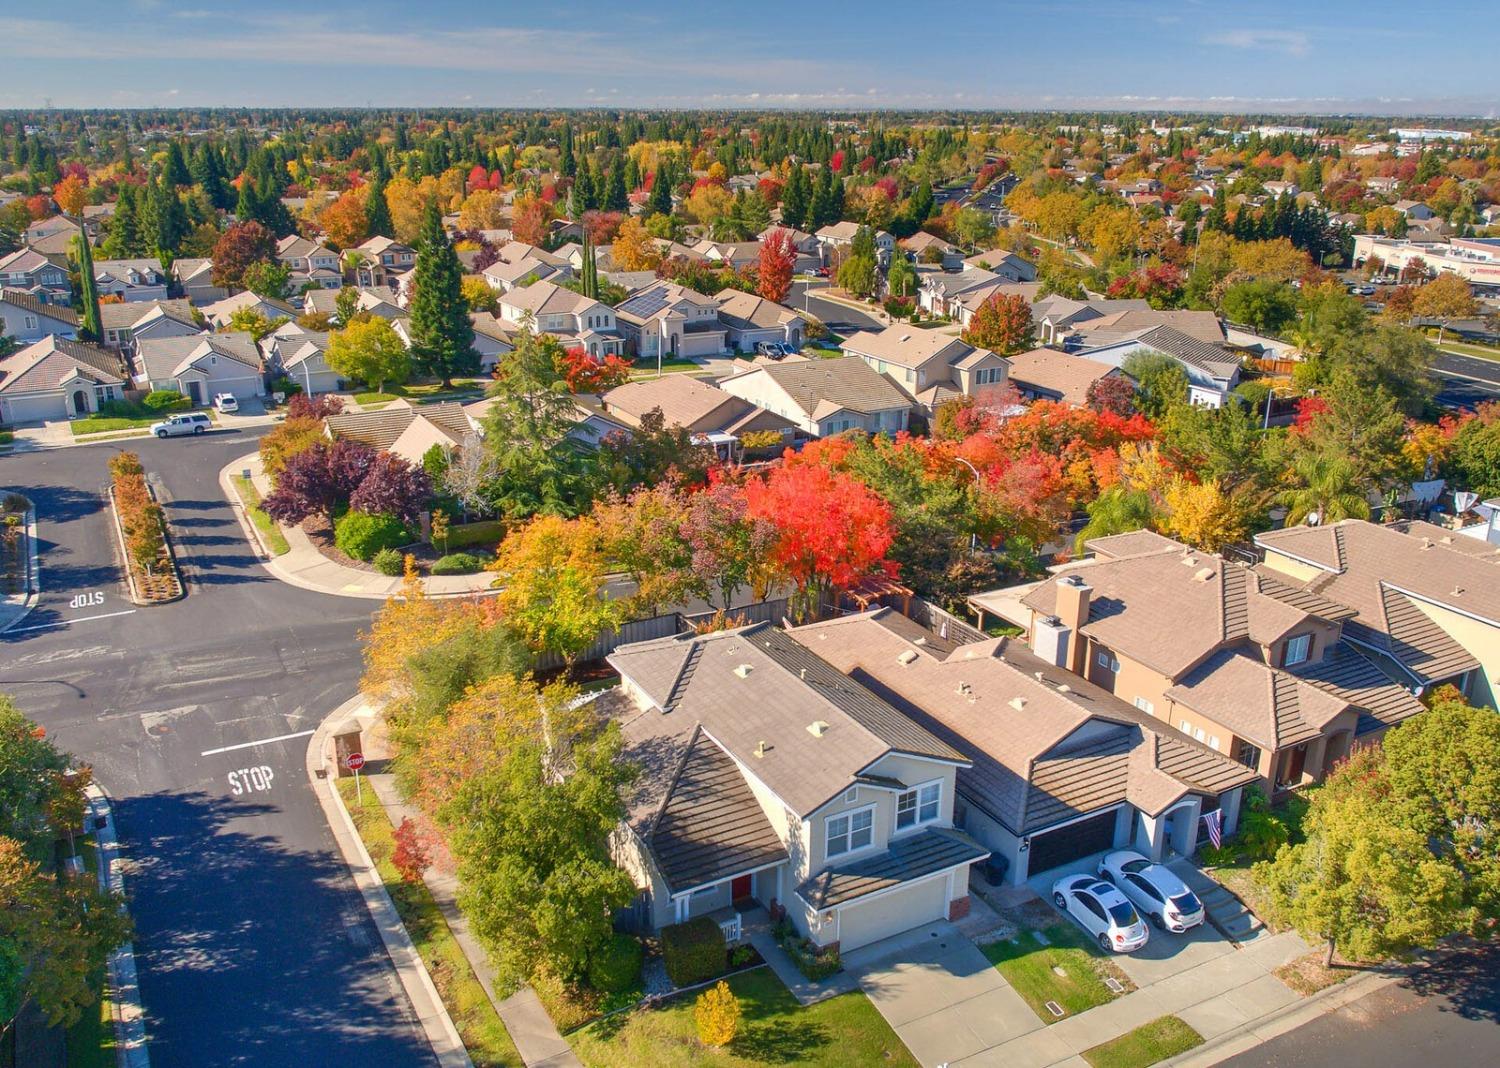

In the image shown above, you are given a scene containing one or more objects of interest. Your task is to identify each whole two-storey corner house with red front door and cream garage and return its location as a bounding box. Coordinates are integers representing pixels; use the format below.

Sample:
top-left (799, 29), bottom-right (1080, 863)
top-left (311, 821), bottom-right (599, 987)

top-left (599, 624), bottom-right (989, 953)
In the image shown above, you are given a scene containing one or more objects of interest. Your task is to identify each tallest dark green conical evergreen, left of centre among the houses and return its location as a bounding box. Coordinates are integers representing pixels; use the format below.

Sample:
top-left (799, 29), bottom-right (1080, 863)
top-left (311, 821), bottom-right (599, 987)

top-left (411, 201), bottom-right (479, 387)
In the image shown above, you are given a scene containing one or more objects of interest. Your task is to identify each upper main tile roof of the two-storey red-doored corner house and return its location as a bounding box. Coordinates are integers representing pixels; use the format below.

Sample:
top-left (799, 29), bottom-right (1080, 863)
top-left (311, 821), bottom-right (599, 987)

top-left (608, 623), bottom-right (965, 816)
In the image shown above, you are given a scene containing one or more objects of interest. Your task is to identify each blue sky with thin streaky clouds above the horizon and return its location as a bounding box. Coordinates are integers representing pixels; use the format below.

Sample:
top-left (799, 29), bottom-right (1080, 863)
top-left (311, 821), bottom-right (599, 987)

top-left (0, 0), bottom-right (1500, 116)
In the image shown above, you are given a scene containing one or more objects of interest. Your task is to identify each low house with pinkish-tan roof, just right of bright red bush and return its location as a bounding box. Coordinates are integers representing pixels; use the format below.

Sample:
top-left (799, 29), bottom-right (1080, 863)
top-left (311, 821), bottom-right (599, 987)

top-left (600, 375), bottom-right (795, 459)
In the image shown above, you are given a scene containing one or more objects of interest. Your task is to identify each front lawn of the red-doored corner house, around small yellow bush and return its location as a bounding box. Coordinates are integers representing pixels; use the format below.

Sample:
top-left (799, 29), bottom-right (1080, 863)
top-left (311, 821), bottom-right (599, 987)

top-left (569, 968), bottom-right (917, 1068)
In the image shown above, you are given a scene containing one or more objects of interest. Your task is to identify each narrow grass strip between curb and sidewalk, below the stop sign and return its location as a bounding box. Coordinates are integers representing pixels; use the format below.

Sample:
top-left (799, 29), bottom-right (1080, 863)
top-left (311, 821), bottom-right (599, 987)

top-left (338, 779), bottom-right (522, 1068)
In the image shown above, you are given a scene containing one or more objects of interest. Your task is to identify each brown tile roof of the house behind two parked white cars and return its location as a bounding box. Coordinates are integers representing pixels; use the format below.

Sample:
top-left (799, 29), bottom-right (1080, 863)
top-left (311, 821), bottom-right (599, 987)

top-left (791, 609), bottom-right (1256, 834)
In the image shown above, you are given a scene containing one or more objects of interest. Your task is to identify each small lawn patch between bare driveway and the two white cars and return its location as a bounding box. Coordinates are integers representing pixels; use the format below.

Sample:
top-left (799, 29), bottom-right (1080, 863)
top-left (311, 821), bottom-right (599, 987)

top-left (980, 924), bottom-right (1131, 1023)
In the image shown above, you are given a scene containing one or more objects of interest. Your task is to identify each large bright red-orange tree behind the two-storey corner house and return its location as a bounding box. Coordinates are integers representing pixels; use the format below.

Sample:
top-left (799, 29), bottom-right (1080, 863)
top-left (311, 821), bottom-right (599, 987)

top-left (744, 464), bottom-right (896, 615)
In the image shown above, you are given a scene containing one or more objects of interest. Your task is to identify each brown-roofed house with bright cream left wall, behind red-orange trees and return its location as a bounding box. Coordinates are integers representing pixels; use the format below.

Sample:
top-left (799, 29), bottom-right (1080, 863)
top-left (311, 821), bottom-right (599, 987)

top-left (719, 356), bottom-right (917, 438)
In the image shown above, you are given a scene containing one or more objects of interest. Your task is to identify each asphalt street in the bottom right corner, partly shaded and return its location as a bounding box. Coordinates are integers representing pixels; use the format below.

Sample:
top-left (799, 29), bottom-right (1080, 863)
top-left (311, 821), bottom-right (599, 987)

top-left (1223, 945), bottom-right (1500, 1068)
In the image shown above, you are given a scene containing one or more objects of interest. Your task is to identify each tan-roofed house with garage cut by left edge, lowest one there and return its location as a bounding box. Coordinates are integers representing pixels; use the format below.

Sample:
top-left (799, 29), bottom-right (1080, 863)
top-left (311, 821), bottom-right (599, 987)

top-left (0, 335), bottom-right (125, 425)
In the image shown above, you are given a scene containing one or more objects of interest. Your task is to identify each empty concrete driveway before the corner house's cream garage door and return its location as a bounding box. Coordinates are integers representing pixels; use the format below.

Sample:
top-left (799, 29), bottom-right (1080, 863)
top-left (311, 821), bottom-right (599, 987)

top-left (845, 923), bottom-right (1043, 1065)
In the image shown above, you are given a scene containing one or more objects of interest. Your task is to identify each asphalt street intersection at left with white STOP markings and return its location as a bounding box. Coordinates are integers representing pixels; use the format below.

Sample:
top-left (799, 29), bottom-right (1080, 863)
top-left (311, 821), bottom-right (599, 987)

top-left (0, 432), bottom-right (432, 1068)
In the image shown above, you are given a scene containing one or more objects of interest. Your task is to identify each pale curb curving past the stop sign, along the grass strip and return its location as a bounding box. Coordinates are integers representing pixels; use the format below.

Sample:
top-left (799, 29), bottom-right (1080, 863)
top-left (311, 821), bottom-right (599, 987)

top-left (306, 695), bottom-right (474, 1068)
